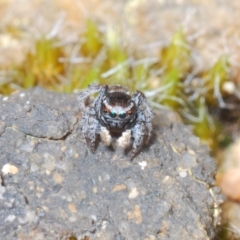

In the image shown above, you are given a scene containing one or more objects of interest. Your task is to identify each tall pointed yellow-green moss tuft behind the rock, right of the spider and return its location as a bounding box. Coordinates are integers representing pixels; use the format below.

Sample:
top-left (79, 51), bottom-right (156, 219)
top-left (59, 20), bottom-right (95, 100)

top-left (154, 30), bottom-right (191, 109)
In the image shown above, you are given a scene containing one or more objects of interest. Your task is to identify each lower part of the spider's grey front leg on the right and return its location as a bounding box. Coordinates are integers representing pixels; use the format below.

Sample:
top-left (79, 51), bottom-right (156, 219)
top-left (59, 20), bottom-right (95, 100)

top-left (131, 122), bottom-right (146, 159)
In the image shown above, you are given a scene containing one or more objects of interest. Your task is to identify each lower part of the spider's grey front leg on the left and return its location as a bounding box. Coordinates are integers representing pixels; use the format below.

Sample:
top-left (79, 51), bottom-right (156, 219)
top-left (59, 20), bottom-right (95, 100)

top-left (82, 108), bottom-right (100, 152)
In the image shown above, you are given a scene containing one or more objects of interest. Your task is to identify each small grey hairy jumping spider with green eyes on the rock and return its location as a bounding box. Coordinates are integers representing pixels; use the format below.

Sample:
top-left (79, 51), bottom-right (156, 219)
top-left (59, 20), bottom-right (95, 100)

top-left (78, 85), bottom-right (153, 159)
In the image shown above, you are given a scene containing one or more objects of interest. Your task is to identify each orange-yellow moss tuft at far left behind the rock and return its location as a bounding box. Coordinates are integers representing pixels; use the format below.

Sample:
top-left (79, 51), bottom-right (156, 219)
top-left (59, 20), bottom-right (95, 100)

top-left (13, 37), bottom-right (65, 89)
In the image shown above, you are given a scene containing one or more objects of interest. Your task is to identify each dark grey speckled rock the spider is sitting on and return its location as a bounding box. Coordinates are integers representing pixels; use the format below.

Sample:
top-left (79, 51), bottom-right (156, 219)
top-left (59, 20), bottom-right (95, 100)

top-left (0, 88), bottom-right (220, 240)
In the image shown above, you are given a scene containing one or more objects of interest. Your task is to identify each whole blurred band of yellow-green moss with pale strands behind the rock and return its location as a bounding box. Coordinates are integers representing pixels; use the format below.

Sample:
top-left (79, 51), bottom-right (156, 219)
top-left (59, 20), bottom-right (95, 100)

top-left (0, 20), bottom-right (230, 153)
